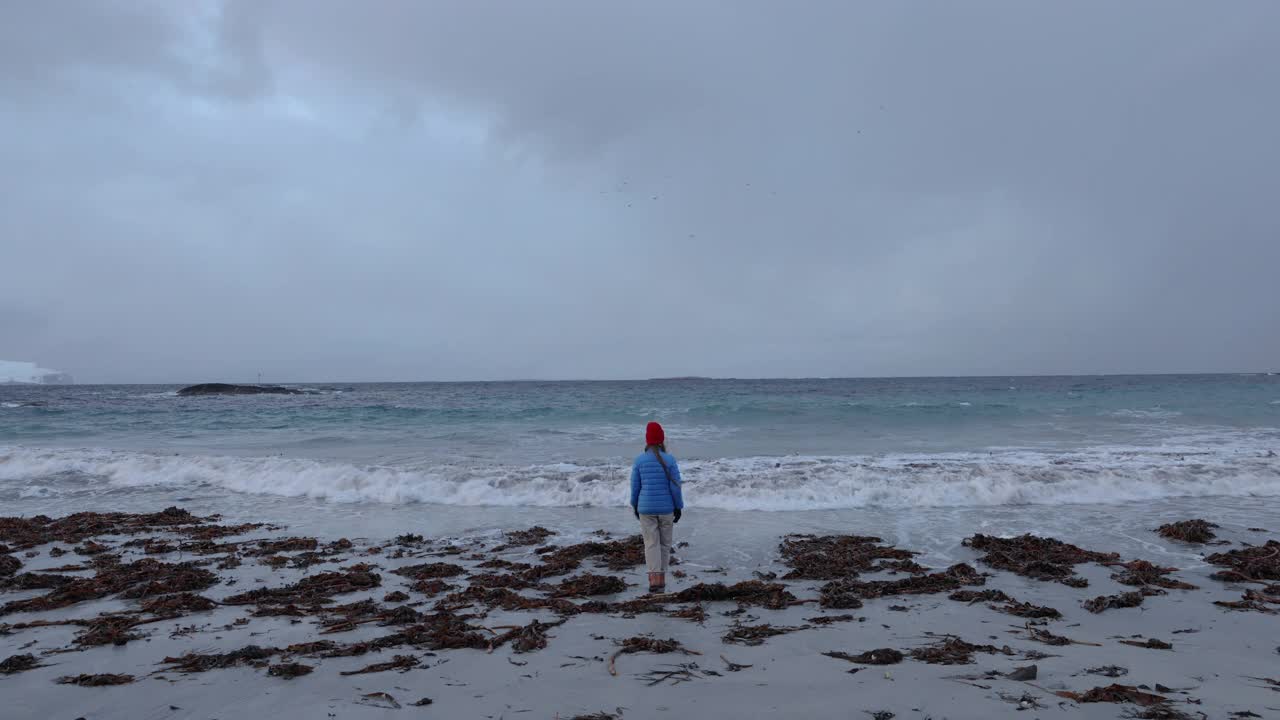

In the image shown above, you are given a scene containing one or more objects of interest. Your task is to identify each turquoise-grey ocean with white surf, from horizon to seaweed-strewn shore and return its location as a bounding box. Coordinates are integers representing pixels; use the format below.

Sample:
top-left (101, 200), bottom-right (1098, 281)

top-left (0, 374), bottom-right (1280, 561)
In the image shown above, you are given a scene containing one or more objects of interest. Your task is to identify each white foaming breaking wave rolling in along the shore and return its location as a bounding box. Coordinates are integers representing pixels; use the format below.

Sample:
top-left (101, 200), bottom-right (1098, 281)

top-left (0, 445), bottom-right (1280, 510)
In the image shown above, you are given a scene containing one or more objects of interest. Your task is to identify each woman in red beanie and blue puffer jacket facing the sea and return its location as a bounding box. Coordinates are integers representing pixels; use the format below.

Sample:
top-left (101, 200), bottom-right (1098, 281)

top-left (631, 423), bottom-right (685, 593)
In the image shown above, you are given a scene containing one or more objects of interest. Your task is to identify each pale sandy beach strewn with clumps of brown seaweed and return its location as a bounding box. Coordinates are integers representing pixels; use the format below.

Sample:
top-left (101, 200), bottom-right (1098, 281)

top-left (0, 509), bottom-right (1280, 720)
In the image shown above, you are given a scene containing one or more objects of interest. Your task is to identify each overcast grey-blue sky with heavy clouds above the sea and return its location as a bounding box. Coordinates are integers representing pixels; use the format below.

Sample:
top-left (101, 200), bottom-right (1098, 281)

top-left (0, 0), bottom-right (1280, 382)
